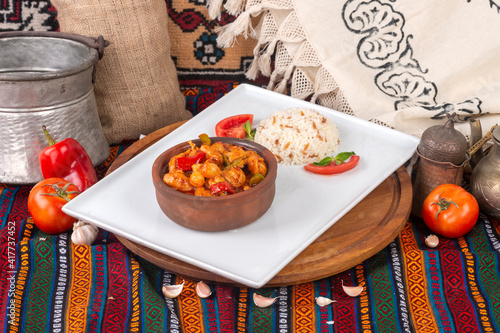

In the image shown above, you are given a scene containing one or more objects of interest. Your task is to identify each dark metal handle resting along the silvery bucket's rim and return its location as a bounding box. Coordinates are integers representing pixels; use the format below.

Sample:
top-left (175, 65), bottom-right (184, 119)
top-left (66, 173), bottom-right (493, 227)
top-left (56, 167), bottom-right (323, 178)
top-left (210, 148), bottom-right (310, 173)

top-left (0, 31), bottom-right (109, 59)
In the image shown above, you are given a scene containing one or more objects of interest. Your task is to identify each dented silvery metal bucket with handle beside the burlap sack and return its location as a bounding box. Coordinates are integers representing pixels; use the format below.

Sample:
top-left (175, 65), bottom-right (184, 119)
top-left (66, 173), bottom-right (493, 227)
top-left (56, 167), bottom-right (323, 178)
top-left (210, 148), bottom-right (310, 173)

top-left (0, 31), bottom-right (110, 184)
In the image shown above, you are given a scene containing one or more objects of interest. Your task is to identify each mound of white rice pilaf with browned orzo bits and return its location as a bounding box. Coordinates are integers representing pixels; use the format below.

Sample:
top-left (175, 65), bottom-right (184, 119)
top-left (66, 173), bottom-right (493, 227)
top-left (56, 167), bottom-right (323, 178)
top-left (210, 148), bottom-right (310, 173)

top-left (255, 108), bottom-right (340, 165)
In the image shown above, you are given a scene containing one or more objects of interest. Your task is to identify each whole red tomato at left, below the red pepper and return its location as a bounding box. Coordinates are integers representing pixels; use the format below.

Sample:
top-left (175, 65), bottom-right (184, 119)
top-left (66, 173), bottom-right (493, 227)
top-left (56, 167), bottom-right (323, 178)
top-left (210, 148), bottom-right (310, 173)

top-left (28, 178), bottom-right (80, 234)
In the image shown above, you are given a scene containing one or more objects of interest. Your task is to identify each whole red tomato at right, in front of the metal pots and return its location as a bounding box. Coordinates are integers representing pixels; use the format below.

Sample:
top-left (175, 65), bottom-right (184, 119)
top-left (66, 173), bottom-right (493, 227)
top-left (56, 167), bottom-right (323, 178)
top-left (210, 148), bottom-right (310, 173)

top-left (422, 184), bottom-right (479, 238)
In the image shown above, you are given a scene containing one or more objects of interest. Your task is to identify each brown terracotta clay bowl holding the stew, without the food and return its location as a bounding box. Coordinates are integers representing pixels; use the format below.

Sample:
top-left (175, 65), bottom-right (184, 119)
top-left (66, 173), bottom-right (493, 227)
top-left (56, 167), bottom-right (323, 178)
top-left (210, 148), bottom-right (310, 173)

top-left (152, 137), bottom-right (278, 231)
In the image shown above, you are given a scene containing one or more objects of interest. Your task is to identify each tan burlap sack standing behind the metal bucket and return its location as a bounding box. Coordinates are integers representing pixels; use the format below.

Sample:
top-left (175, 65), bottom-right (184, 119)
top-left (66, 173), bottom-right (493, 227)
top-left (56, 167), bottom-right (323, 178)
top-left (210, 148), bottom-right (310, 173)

top-left (51, 0), bottom-right (191, 144)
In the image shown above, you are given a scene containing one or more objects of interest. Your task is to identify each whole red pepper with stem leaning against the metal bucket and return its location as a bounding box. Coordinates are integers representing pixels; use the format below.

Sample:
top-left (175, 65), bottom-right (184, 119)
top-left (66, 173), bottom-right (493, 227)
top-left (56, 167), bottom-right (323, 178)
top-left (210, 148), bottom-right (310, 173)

top-left (39, 126), bottom-right (97, 192)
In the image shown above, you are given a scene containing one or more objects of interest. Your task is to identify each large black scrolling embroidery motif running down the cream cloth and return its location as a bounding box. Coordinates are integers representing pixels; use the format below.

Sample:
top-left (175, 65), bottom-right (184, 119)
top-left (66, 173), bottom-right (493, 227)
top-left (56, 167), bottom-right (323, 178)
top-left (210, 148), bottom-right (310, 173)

top-left (342, 0), bottom-right (482, 119)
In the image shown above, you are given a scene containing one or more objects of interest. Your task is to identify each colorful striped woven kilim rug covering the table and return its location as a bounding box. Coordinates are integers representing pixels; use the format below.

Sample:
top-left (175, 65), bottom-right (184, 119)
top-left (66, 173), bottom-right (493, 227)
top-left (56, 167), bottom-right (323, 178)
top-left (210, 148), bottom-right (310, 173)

top-left (0, 84), bottom-right (500, 333)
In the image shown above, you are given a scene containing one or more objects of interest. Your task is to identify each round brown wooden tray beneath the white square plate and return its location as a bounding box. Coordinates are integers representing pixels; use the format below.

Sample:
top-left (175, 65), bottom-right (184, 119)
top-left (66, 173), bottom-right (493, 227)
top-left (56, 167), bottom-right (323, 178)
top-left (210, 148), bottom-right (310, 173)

top-left (107, 122), bottom-right (412, 287)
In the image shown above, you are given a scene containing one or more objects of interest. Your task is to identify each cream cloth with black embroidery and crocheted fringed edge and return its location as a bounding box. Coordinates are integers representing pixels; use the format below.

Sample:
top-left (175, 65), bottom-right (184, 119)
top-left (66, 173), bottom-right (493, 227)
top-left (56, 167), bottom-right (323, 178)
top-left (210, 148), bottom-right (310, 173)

top-left (208, 0), bottom-right (500, 136)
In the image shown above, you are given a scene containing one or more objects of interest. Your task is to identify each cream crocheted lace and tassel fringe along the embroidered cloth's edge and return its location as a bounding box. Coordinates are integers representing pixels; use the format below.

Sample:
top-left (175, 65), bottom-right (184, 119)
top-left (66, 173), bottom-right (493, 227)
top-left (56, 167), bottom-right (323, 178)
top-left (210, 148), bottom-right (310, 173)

top-left (215, 0), bottom-right (332, 101)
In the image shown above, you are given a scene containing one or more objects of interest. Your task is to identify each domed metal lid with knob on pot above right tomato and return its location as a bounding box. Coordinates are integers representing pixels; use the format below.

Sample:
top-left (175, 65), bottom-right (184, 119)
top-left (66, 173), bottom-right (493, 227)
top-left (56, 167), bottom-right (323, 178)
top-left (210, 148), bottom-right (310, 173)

top-left (418, 113), bottom-right (468, 165)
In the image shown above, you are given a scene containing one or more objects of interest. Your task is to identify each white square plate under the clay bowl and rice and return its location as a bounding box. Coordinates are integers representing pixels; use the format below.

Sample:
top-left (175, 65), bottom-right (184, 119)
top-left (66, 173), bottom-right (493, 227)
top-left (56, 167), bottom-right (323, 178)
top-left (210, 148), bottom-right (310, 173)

top-left (63, 84), bottom-right (419, 288)
